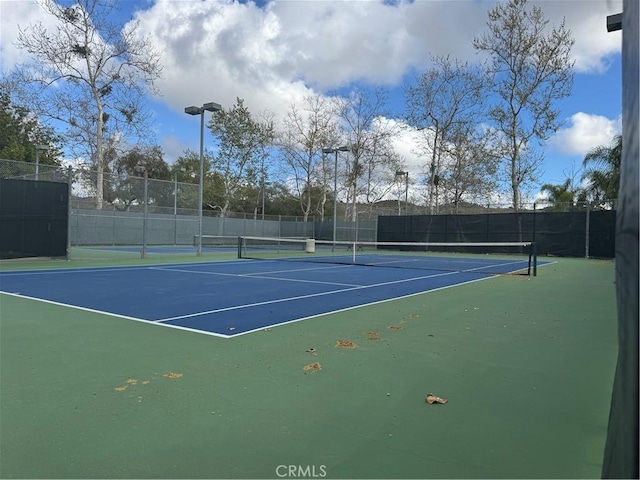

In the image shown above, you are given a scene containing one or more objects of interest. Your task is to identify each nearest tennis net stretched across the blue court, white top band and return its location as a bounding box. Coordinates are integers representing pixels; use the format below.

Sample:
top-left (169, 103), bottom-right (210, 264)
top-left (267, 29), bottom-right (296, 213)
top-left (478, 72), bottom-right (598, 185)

top-left (238, 236), bottom-right (537, 275)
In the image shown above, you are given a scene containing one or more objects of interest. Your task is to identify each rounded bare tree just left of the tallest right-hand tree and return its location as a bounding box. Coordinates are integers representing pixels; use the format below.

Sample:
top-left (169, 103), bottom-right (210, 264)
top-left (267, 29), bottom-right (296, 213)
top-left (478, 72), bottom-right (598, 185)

top-left (405, 56), bottom-right (487, 213)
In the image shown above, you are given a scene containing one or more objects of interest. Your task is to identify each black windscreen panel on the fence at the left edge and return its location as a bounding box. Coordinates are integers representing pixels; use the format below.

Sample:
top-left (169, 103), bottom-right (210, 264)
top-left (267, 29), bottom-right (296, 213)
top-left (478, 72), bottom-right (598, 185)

top-left (0, 179), bottom-right (69, 259)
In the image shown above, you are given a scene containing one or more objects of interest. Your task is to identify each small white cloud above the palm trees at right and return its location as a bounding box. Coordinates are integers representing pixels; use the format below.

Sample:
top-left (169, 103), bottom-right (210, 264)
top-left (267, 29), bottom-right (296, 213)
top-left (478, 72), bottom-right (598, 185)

top-left (549, 112), bottom-right (621, 156)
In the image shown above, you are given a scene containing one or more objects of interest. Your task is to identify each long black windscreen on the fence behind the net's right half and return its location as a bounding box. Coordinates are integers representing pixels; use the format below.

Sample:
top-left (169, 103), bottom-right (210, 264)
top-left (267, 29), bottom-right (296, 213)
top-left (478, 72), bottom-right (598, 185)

top-left (377, 210), bottom-right (615, 258)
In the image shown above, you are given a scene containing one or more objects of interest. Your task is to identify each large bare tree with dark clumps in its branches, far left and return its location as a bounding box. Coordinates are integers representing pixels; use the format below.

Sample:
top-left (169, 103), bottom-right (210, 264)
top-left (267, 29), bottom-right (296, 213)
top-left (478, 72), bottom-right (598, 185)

top-left (13, 0), bottom-right (161, 208)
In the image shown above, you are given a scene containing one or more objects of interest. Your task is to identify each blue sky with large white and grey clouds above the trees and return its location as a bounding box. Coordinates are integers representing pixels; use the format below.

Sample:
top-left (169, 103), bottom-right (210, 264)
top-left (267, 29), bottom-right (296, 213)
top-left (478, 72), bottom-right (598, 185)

top-left (0, 0), bottom-right (622, 201)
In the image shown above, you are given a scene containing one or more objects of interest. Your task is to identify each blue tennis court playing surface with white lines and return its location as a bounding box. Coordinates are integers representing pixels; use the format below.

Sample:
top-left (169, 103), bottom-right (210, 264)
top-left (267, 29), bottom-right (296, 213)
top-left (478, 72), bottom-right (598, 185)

top-left (0, 260), bottom-right (536, 337)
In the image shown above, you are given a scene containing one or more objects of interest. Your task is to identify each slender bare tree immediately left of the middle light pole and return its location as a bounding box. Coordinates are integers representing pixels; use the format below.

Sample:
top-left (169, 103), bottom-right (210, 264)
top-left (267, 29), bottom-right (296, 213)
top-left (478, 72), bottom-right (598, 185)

top-left (277, 95), bottom-right (339, 222)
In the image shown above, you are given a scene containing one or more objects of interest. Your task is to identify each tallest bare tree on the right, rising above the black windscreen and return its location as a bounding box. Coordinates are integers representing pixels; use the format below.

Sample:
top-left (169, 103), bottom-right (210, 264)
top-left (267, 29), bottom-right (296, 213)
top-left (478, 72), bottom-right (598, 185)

top-left (473, 0), bottom-right (574, 211)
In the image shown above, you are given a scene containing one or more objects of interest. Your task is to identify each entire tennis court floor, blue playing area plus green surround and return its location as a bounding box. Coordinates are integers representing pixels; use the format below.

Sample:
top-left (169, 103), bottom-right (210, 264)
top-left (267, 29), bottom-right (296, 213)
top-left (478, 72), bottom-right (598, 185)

top-left (0, 245), bottom-right (616, 478)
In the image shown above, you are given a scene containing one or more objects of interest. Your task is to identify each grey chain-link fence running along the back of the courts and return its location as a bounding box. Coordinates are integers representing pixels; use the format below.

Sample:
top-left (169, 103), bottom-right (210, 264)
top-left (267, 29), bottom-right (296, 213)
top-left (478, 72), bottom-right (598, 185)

top-left (0, 159), bottom-right (615, 258)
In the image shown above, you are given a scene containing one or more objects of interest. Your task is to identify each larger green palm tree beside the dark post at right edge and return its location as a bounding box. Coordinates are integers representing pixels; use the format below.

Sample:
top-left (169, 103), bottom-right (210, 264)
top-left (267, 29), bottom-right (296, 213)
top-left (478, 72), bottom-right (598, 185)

top-left (582, 135), bottom-right (622, 203)
